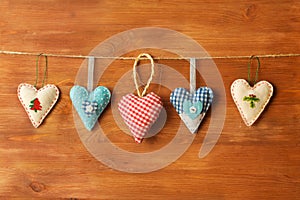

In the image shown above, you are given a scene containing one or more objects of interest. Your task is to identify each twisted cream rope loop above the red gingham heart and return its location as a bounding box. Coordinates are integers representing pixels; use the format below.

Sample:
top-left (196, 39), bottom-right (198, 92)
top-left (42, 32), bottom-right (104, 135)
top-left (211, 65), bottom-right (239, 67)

top-left (133, 53), bottom-right (154, 97)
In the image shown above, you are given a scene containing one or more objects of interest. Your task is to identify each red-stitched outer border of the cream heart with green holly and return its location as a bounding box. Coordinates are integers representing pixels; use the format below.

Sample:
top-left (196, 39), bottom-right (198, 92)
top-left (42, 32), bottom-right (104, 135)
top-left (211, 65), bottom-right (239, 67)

top-left (230, 79), bottom-right (273, 126)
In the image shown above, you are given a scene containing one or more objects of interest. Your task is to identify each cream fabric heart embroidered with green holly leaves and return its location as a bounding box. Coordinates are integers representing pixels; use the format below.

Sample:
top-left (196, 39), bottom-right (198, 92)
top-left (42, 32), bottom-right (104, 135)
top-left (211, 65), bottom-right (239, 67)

top-left (231, 79), bottom-right (273, 126)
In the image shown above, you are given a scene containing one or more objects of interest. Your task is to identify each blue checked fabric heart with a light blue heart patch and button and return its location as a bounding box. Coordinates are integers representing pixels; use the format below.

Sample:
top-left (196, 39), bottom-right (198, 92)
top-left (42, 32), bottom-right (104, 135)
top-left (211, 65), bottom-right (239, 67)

top-left (170, 87), bottom-right (213, 133)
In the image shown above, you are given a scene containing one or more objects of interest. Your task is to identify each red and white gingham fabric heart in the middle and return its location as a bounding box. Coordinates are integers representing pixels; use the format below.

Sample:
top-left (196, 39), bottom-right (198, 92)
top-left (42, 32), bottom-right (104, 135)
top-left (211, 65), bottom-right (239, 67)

top-left (118, 92), bottom-right (163, 143)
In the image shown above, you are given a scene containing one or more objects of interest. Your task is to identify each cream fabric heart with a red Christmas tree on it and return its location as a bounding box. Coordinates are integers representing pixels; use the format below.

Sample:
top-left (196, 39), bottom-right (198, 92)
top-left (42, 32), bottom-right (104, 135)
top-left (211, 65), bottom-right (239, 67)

top-left (18, 83), bottom-right (59, 128)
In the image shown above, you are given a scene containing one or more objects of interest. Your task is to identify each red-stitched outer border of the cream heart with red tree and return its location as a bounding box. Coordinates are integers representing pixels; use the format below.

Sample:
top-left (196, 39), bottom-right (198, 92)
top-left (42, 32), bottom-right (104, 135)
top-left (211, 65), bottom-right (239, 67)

top-left (17, 83), bottom-right (59, 128)
